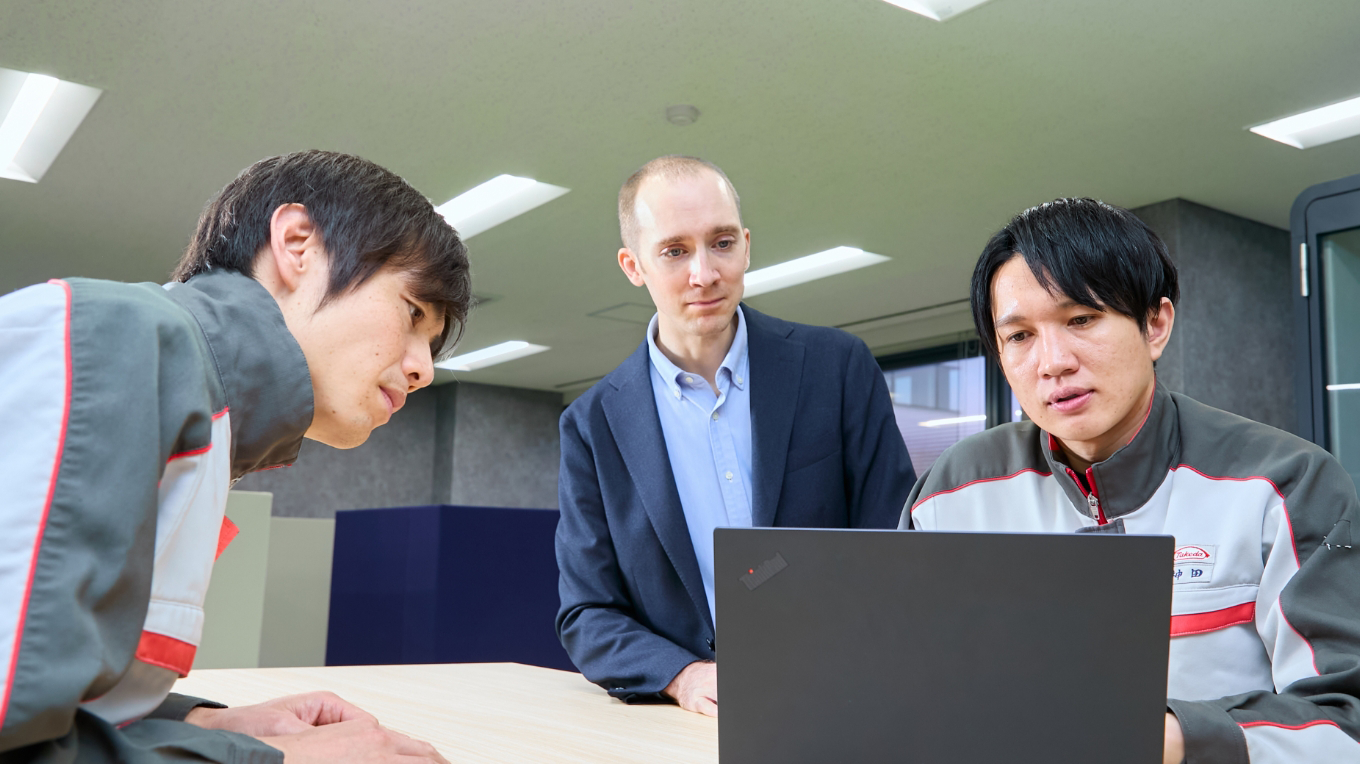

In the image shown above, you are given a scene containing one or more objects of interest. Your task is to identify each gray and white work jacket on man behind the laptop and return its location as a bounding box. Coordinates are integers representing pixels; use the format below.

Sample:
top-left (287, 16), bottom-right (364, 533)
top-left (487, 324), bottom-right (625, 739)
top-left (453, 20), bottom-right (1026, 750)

top-left (902, 385), bottom-right (1360, 764)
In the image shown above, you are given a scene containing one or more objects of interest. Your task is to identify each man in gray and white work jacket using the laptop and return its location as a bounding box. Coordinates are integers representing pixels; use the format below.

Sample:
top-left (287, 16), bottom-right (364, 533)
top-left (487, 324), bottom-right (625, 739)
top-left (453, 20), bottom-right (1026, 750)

top-left (902, 198), bottom-right (1360, 764)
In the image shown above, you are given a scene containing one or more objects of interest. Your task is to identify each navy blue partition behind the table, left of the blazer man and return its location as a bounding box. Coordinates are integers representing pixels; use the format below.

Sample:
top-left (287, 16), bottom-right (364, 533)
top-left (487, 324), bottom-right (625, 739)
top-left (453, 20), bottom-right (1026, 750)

top-left (326, 506), bottom-right (575, 670)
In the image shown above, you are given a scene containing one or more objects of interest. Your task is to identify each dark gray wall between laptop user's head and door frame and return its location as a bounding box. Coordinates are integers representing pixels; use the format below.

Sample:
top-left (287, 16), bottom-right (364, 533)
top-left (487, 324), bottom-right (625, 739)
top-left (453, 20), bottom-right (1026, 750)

top-left (1133, 198), bottom-right (1297, 432)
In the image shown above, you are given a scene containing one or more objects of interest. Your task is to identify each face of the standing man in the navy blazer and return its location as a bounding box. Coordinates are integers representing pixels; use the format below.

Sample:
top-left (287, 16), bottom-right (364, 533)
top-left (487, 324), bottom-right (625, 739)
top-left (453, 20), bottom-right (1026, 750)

top-left (619, 171), bottom-right (751, 337)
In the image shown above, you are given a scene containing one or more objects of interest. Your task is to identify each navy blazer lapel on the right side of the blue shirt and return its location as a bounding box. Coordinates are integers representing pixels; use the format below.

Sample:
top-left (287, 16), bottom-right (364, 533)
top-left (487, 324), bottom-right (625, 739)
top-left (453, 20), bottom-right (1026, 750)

top-left (741, 305), bottom-right (802, 527)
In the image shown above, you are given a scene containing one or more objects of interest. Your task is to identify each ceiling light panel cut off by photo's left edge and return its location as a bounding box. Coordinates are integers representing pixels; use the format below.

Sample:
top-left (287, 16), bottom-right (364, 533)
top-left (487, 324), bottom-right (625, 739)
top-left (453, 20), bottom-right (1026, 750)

top-left (0, 69), bottom-right (101, 184)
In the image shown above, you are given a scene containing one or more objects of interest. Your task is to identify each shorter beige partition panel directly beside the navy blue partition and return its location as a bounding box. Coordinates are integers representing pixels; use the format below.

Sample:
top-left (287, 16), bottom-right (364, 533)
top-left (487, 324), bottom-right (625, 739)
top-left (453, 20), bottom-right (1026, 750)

top-left (260, 518), bottom-right (336, 666)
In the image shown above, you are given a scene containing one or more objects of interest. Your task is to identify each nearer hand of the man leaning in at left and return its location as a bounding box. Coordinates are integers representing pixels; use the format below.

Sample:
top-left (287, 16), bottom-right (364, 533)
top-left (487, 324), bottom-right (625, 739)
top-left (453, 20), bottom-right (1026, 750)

top-left (260, 718), bottom-right (449, 764)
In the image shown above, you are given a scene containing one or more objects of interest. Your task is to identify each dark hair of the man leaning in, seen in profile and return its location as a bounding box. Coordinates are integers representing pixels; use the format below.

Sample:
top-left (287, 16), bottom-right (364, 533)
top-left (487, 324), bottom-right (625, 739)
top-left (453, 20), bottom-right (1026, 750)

top-left (171, 151), bottom-right (472, 359)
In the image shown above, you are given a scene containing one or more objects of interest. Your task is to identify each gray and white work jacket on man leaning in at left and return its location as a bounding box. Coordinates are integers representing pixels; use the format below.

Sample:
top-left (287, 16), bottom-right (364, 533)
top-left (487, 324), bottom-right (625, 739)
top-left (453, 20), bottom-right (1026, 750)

top-left (0, 272), bottom-right (313, 763)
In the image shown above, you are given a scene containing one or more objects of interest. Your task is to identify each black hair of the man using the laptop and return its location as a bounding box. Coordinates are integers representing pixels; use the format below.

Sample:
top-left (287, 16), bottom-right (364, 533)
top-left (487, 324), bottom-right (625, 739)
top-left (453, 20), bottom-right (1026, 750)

top-left (972, 198), bottom-right (1180, 359)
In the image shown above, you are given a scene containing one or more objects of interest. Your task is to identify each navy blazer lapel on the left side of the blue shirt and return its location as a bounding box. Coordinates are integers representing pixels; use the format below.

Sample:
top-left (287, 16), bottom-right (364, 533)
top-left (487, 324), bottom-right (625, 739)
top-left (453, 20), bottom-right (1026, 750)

top-left (602, 341), bottom-right (710, 621)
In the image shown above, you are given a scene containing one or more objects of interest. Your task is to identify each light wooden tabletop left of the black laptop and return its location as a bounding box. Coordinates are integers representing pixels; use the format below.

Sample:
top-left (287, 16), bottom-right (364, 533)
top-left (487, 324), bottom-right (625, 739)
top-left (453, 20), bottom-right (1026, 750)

top-left (174, 663), bottom-right (718, 764)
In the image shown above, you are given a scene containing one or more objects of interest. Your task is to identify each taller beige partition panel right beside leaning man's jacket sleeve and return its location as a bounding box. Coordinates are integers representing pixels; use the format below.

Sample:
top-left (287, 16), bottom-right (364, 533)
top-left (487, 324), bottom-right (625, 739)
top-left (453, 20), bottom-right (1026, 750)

top-left (193, 491), bottom-right (273, 669)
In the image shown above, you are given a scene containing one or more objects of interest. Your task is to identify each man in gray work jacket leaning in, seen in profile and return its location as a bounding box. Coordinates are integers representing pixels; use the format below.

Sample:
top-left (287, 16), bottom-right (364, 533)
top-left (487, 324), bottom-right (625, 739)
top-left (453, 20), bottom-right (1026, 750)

top-left (0, 151), bottom-right (469, 763)
